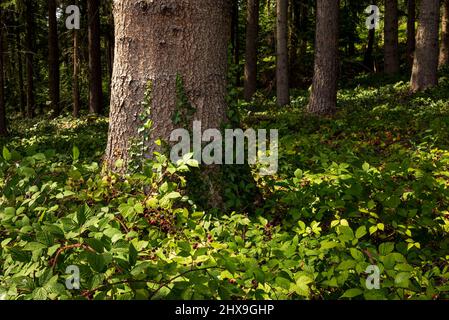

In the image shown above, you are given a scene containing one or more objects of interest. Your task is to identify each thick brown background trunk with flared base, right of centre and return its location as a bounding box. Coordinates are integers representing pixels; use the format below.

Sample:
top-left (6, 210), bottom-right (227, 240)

top-left (308, 0), bottom-right (339, 114)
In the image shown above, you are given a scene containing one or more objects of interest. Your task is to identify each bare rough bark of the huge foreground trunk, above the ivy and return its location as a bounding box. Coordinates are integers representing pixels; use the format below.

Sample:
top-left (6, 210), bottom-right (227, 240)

top-left (105, 0), bottom-right (231, 170)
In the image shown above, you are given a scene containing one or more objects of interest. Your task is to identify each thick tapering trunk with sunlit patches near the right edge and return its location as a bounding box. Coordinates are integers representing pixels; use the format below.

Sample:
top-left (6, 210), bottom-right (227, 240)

top-left (411, 0), bottom-right (440, 91)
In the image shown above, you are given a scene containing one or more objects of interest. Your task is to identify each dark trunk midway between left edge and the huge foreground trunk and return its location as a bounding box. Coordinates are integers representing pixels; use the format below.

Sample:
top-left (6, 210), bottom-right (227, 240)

top-left (48, 0), bottom-right (60, 116)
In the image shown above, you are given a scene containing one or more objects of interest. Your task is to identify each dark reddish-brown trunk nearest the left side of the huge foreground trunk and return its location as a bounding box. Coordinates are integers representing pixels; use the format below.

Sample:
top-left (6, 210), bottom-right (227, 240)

top-left (87, 0), bottom-right (103, 114)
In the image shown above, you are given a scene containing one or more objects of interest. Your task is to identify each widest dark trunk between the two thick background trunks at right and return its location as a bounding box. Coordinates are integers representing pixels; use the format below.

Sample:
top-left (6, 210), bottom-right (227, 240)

top-left (384, 0), bottom-right (399, 74)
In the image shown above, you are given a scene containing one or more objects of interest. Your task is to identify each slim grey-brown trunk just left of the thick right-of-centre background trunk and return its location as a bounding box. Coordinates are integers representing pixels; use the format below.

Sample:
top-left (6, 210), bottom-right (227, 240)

top-left (276, 0), bottom-right (290, 106)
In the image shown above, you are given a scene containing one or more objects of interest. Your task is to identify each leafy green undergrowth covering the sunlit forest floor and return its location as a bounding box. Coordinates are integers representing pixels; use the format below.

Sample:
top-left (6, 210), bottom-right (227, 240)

top-left (0, 75), bottom-right (449, 299)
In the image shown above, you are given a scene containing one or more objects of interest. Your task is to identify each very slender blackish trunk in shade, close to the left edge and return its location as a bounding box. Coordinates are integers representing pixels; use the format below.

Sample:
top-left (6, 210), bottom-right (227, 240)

top-left (25, 0), bottom-right (35, 118)
